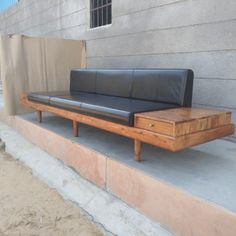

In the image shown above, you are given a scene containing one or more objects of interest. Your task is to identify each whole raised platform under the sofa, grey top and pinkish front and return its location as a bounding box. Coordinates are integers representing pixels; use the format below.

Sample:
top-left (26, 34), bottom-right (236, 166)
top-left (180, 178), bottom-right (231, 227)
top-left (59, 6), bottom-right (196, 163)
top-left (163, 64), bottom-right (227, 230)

top-left (2, 114), bottom-right (236, 236)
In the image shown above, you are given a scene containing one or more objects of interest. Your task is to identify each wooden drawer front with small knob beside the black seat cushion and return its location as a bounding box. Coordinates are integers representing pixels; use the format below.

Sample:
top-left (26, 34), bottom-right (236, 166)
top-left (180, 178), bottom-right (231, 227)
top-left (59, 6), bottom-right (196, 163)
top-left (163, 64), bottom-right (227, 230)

top-left (134, 116), bottom-right (174, 136)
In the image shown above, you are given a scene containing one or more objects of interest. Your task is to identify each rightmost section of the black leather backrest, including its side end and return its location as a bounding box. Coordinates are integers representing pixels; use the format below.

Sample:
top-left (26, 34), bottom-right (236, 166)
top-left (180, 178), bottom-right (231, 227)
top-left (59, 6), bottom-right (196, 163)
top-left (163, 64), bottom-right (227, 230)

top-left (131, 69), bottom-right (193, 106)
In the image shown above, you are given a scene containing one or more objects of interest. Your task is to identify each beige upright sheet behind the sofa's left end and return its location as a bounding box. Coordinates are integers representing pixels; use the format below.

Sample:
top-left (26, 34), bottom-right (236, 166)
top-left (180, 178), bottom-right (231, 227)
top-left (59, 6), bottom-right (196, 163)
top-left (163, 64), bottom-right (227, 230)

top-left (0, 35), bottom-right (86, 115)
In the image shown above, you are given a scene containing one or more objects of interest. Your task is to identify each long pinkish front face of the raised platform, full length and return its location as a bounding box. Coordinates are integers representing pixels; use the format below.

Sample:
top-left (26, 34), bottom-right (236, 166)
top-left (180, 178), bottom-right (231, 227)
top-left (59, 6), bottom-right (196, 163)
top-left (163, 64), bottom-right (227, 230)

top-left (0, 111), bottom-right (236, 236)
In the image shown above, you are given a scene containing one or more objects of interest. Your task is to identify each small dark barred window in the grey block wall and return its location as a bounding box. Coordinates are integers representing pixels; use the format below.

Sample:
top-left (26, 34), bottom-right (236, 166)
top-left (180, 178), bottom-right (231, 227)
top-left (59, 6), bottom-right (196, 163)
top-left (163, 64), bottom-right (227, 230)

top-left (90, 0), bottom-right (112, 28)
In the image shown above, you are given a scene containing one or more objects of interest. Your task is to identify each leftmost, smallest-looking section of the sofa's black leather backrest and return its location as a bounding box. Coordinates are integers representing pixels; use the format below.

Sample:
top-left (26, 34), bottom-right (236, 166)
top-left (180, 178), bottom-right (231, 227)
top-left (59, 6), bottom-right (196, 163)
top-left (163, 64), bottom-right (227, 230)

top-left (70, 69), bottom-right (97, 93)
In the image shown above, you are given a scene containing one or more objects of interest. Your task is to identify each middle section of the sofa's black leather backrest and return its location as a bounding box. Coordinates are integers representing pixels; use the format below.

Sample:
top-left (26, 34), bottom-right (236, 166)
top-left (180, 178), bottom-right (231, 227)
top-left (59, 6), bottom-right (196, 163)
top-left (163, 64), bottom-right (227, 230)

top-left (96, 70), bottom-right (133, 97)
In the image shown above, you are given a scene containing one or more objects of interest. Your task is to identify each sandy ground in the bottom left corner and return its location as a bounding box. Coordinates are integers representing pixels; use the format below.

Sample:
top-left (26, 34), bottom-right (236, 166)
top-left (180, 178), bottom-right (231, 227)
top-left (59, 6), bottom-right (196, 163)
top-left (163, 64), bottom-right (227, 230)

top-left (0, 152), bottom-right (103, 236)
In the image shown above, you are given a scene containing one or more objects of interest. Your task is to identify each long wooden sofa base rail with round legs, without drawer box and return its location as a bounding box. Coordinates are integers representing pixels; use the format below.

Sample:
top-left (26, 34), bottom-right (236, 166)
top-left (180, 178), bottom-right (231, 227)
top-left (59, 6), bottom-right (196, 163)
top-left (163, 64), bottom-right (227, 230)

top-left (21, 93), bottom-right (234, 161)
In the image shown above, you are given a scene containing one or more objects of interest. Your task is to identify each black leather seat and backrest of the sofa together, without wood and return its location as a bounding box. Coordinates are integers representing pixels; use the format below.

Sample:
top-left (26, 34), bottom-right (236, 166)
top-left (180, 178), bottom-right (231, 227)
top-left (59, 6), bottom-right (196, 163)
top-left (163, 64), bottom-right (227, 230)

top-left (28, 69), bottom-right (194, 126)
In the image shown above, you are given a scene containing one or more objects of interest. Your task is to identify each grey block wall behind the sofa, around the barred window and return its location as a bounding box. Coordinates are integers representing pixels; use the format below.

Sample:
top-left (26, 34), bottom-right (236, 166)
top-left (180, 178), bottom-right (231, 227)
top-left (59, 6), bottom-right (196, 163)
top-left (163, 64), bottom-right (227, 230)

top-left (0, 0), bottom-right (236, 127)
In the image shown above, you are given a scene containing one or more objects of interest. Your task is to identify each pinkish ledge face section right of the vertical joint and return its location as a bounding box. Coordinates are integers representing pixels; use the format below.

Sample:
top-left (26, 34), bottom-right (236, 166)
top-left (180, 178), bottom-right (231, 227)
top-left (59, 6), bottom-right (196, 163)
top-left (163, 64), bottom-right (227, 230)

top-left (107, 160), bottom-right (236, 236)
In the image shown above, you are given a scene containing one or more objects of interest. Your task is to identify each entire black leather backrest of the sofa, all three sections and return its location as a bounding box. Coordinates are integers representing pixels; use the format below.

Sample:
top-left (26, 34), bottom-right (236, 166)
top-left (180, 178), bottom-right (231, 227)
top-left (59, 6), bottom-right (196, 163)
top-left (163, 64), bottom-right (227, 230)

top-left (70, 69), bottom-right (193, 106)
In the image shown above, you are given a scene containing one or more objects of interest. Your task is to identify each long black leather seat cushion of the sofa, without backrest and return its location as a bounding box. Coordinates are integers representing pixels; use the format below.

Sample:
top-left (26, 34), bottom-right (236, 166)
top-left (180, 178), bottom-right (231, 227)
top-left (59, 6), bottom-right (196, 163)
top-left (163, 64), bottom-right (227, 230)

top-left (29, 92), bottom-right (177, 126)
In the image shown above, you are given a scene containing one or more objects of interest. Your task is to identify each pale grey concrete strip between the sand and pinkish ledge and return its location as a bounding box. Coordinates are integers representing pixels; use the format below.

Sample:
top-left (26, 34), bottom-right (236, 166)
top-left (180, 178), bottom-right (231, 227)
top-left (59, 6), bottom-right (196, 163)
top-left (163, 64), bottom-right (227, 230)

top-left (0, 122), bottom-right (173, 236)
